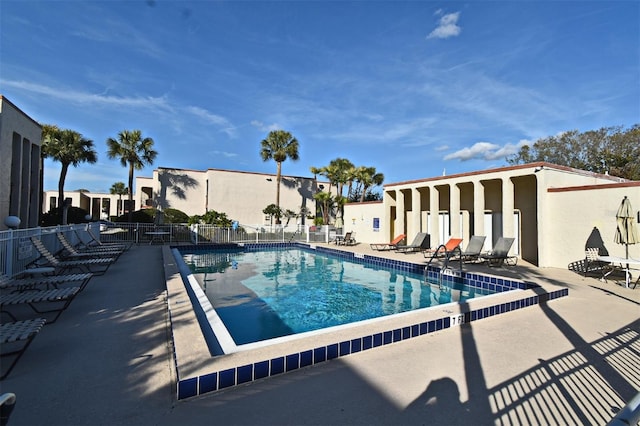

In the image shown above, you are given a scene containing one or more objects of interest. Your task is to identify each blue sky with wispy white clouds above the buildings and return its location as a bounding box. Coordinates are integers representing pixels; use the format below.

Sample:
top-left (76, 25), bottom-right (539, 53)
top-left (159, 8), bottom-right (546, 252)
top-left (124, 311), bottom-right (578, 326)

top-left (0, 0), bottom-right (640, 192)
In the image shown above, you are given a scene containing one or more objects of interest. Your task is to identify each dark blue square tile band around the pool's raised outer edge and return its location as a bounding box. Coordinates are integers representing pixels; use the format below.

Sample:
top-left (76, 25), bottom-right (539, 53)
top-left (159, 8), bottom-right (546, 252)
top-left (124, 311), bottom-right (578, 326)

top-left (170, 243), bottom-right (569, 400)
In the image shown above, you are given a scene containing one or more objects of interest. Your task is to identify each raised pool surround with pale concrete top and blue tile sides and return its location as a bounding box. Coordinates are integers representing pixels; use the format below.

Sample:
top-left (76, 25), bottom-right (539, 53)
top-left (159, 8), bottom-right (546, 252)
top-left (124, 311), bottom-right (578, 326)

top-left (162, 243), bottom-right (569, 400)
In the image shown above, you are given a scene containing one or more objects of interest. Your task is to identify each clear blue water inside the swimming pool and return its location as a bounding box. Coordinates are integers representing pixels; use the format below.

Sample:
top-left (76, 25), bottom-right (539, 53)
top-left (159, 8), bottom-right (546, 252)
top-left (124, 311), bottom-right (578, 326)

top-left (182, 249), bottom-right (487, 345)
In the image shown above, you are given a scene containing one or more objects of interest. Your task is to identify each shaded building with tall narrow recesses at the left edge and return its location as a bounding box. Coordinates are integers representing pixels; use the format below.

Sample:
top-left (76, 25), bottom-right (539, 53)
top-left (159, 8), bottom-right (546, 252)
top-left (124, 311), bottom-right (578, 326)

top-left (0, 95), bottom-right (42, 230)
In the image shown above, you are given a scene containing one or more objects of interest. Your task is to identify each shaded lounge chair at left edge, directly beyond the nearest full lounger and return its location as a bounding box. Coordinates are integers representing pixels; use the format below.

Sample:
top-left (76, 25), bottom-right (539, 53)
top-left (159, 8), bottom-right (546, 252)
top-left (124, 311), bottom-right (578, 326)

top-left (0, 287), bottom-right (80, 324)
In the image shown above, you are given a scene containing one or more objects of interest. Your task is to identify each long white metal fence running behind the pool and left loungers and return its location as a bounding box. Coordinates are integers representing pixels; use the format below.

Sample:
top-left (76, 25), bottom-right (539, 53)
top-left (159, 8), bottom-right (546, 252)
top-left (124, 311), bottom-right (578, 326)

top-left (0, 223), bottom-right (339, 276)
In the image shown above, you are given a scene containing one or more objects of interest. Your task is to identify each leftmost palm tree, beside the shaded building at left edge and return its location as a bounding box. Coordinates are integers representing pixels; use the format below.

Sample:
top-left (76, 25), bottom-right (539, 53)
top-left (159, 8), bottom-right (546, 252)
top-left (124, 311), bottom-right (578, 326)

top-left (42, 124), bottom-right (98, 225)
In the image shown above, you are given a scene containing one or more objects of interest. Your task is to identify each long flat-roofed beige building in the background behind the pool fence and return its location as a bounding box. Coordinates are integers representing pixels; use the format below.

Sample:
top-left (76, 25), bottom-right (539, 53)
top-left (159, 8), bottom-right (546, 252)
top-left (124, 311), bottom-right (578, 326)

top-left (44, 167), bottom-right (327, 228)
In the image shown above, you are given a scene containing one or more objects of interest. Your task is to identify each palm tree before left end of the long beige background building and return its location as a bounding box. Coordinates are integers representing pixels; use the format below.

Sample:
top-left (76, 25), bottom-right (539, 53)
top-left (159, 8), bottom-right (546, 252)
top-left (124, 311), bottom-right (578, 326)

top-left (107, 130), bottom-right (158, 222)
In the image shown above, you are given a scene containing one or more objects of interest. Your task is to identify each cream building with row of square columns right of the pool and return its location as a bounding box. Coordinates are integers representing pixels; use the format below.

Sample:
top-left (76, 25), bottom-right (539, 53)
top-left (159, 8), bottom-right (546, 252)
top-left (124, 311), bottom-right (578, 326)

top-left (344, 163), bottom-right (640, 268)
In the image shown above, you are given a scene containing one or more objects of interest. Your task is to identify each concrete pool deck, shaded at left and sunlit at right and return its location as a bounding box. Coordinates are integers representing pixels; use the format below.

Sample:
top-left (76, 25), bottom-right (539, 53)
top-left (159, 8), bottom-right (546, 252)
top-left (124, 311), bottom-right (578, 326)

top-left (0, 244), bottom-right (640, 425)
